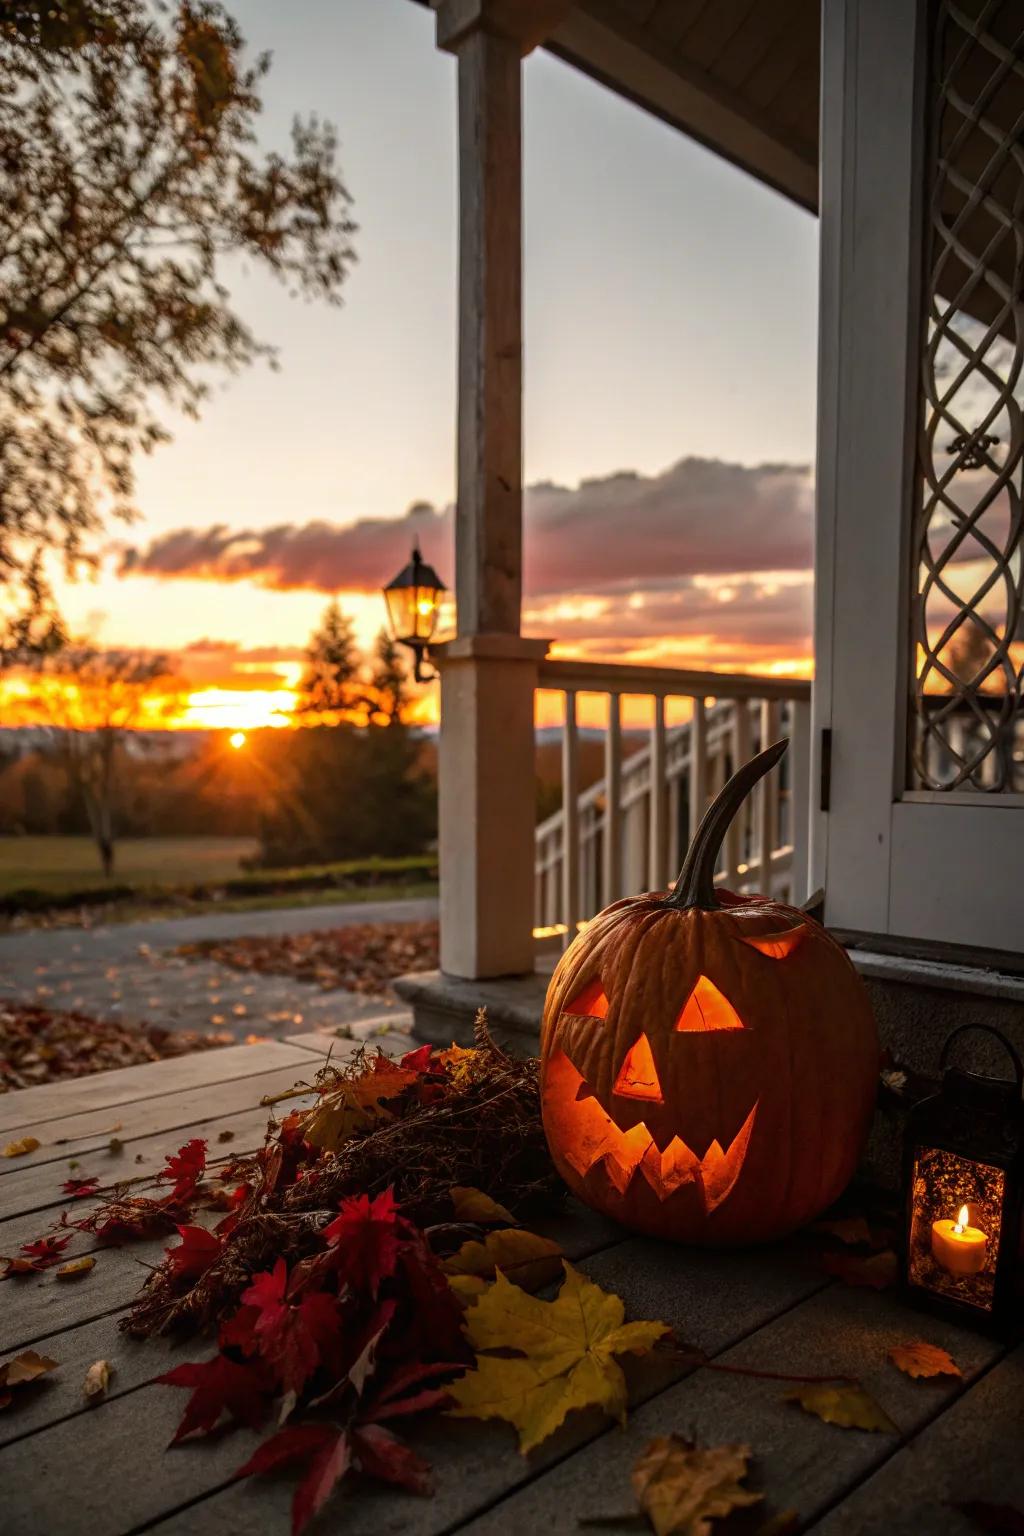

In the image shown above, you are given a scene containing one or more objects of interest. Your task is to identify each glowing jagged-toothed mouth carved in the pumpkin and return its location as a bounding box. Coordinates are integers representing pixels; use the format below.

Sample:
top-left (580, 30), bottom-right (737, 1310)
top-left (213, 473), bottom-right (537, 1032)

top-left (543, 1051), bottom-right (758, 1212)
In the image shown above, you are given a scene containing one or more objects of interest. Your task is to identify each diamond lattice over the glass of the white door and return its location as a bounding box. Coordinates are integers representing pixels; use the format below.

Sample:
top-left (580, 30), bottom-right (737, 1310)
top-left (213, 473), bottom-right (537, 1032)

top-left (910, 0), bottom-right (1024, 793)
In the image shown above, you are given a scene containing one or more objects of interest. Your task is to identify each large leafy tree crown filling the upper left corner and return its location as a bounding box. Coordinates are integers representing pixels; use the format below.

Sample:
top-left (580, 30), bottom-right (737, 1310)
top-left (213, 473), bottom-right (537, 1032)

top-left (0, 0), bottom-right (355, 645)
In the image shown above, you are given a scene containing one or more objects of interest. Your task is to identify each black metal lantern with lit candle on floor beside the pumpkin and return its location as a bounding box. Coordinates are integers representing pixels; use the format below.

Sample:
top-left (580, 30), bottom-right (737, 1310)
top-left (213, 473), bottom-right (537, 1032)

top-left (904, 1025), bottom-right (1024, 1333)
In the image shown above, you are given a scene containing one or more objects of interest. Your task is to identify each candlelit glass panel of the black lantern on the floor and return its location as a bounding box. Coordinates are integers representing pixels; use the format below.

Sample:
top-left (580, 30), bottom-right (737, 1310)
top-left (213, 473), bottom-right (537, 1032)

top-left (907, 1147), bottom-right (1006, 1312)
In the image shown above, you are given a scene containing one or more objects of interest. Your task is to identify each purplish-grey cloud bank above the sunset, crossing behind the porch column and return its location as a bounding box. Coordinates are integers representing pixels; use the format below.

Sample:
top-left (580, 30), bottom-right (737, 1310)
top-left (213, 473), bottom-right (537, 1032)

top-left (121, 458), bottom-right (814, 599)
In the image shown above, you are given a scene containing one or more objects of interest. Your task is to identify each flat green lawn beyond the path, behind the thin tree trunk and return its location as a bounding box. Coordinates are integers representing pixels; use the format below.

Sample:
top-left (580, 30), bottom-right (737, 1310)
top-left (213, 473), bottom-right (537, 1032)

top-left (0, 837), bottom-right (256, 895)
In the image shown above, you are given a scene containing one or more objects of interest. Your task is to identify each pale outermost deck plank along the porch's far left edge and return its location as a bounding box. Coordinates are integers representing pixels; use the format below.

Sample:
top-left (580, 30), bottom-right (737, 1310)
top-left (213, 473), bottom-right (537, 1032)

top-left (0, 1040), bottom-right (316, 1134)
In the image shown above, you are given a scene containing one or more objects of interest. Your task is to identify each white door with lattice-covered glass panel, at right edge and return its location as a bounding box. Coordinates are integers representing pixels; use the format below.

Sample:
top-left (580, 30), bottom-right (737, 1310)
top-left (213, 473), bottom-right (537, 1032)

top-left (814, 0), bottom-right (1024, 951)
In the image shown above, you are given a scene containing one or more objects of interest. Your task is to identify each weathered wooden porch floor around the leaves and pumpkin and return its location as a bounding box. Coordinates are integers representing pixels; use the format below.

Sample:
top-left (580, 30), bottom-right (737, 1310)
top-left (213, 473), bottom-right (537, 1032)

top-left (0, 1035), bottom-right (1024, 1536)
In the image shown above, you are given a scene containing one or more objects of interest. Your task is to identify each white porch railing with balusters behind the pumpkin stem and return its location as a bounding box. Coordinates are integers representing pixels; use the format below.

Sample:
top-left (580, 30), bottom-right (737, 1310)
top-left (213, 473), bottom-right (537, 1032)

top-left (534, 660), bottom-right (811, 934)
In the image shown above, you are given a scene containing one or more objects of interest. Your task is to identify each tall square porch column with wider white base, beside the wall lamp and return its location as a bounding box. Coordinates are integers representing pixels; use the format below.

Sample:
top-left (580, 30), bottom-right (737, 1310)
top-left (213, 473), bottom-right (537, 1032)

top-left (433, 0), bottom-right (568, 978)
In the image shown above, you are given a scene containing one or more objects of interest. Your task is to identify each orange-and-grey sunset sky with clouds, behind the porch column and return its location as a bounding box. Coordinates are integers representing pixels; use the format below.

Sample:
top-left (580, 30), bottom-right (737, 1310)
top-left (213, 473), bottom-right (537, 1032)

top-left (3, 0), bottom-right (817, 730)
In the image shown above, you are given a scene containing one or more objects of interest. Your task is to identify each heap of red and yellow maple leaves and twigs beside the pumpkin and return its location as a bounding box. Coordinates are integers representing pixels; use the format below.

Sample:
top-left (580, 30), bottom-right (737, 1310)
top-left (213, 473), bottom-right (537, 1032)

top-left (8, 1021), bottom-right (668, 1533)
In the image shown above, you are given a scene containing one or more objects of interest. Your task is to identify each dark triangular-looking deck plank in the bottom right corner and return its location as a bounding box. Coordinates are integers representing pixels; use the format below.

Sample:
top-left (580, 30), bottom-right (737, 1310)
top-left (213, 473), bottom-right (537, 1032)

top-left (812, 1333), bottom-right (1024, 1536)
